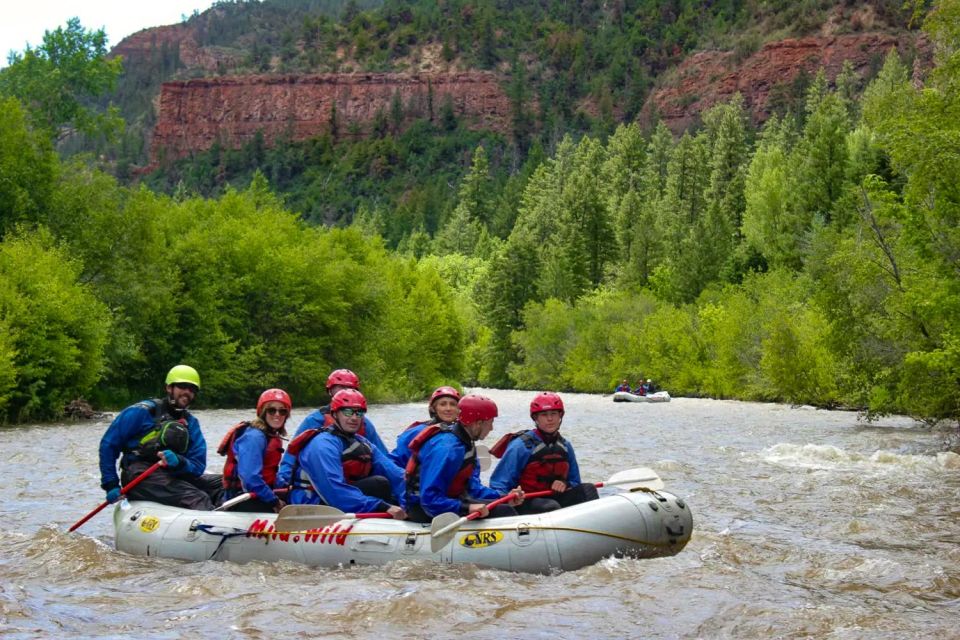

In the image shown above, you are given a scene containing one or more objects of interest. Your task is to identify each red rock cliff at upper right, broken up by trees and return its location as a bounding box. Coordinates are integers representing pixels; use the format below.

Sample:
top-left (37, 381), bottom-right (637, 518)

top-left (643, 33), bottom-right (929, 133)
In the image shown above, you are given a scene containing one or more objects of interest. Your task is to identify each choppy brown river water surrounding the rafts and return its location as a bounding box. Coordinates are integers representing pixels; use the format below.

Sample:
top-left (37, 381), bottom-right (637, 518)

top-left (0, 390), bottom-right (960, 640)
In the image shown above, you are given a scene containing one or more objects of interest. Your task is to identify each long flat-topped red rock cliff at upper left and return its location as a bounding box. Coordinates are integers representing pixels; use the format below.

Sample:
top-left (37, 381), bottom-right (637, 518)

top-left (151, 71), bottom-right (510, 159)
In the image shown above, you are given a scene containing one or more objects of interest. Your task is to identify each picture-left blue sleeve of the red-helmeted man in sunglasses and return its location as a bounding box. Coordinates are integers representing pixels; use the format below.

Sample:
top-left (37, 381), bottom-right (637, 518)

top-left (300, 433), bottom-right (382, 513)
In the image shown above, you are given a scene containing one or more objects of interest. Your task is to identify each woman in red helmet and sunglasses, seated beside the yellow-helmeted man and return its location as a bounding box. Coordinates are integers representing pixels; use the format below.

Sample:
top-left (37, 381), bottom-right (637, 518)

top-left (217, 389), bottom-right (293, 513)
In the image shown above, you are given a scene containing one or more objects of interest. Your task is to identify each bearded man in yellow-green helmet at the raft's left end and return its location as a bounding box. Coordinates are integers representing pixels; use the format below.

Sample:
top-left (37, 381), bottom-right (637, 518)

top-left (100, 364), bottom-right (222, 511)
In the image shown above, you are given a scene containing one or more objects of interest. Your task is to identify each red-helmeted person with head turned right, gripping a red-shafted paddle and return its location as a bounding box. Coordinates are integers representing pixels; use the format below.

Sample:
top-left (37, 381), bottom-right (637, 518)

top-left (406, 394), bottom-right (523, 522)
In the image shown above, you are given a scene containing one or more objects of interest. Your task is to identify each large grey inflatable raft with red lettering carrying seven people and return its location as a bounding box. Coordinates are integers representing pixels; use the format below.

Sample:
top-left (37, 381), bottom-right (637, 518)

top-left (114, 489), bottom-right (693, 573)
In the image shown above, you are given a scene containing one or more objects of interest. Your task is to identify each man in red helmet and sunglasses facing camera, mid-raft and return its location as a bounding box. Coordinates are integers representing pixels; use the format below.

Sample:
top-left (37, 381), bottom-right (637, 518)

top-left (287, 389), bottom-right (407, 520)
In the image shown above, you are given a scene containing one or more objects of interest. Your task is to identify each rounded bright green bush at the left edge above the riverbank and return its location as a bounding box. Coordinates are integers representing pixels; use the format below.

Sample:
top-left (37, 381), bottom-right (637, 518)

top-left (0, 231), bottom-right (110, 422)
